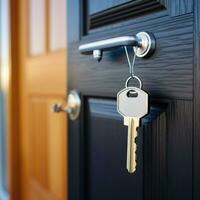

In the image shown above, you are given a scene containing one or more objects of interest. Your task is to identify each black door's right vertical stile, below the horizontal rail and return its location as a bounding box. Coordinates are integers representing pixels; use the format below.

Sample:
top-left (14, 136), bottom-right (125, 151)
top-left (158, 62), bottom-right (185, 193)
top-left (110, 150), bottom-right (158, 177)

top-left (167, 101), bottom-right (193, 200)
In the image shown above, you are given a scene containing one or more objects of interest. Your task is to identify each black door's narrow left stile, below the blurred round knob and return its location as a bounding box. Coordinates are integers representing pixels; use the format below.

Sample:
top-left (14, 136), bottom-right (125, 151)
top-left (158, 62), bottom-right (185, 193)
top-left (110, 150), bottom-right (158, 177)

top-left (68, 104), bottom-right (82, 200)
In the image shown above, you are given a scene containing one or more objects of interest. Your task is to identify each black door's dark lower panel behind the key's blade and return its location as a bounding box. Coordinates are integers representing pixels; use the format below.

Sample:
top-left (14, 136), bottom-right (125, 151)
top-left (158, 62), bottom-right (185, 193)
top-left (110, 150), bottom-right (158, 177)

top-left (84, 98), bottom-right (143, 200)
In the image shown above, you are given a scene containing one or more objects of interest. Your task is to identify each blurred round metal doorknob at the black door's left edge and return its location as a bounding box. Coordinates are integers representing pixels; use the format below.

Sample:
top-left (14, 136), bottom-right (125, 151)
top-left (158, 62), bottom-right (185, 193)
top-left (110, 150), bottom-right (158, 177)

top-left (51, 90), bottom-right (81, 120)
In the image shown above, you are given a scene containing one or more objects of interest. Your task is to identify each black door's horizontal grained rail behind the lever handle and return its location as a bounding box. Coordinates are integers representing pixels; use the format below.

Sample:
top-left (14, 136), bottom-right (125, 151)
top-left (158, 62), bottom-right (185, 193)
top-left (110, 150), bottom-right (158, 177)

top-left (69, 14), bottom-right (193, 99)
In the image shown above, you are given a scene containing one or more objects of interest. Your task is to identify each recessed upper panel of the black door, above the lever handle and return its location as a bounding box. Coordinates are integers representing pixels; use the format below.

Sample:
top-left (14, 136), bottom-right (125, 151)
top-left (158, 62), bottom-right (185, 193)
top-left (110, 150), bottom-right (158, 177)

top-left (88, 0), bottom-right (193, 30)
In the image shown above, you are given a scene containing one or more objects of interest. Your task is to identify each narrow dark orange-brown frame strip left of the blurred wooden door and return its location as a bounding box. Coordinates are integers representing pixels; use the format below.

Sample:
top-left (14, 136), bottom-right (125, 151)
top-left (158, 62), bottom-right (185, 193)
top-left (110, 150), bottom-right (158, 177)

top-left (8, 0), bottom-right (21, 200)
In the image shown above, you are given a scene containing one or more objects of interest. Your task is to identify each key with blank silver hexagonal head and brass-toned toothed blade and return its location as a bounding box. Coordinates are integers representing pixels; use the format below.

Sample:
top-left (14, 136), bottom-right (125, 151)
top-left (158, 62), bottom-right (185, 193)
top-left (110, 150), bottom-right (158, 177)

top-left (117, 87), bottom-right (148, 173)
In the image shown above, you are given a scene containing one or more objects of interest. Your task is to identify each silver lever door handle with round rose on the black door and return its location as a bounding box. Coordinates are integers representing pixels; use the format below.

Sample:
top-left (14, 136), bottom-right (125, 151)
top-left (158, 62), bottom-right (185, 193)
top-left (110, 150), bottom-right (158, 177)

top-left (79, 32), bottom-right (156, 61)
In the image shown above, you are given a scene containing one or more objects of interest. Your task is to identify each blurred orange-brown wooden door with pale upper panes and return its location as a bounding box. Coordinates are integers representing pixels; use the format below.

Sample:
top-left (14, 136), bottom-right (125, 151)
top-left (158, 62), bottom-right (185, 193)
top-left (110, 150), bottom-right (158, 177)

top-left (17, 0), bottom-right (67, 200)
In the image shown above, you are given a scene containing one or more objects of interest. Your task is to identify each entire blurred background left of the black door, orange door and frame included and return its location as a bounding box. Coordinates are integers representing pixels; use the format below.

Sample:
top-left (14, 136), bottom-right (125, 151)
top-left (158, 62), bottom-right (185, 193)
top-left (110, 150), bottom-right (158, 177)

top-left (0, 0), bottom-right (67, 200)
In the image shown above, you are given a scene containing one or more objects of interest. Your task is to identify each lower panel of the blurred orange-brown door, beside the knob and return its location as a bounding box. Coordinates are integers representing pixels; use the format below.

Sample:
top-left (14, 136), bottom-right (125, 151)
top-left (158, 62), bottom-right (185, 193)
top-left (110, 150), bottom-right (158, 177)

top-left (29, 96), bottom-right (66, 199)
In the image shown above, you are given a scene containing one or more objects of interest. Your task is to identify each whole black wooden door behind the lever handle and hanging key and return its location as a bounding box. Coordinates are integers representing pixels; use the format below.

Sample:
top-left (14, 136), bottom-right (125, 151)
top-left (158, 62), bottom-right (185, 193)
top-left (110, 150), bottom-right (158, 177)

top-left (67, 0), bottom-right (200, 200)
